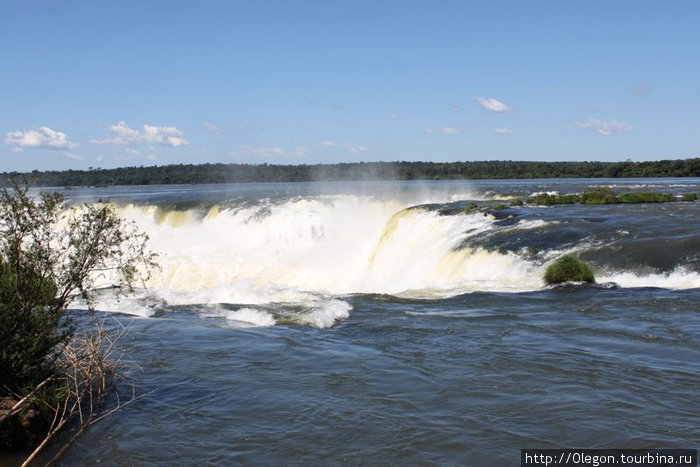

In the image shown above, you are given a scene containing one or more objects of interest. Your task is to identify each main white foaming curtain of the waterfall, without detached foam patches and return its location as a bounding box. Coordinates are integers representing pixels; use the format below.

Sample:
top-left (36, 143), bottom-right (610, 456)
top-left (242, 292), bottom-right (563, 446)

top-left (112, 196), bottom-right (533, 304)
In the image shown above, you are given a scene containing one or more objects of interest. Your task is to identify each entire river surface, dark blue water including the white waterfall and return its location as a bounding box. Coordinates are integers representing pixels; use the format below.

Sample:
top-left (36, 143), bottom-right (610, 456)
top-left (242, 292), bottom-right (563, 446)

top-left (31, 179), bottom-right (700, 466)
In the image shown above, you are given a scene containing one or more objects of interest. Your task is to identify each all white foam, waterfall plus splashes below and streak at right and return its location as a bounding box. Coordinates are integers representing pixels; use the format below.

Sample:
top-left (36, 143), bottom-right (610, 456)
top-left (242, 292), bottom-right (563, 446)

top-left (76, 189), bottom-right (700, 327)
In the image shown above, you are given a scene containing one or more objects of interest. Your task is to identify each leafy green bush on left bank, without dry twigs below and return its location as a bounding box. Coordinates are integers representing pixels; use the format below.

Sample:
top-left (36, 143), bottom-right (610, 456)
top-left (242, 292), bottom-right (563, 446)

top-left (0, 182), bottom-right (155, 397)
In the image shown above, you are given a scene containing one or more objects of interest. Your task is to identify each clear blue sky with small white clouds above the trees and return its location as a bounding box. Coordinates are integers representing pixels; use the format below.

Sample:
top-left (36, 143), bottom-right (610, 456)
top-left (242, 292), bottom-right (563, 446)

top-left (0, 0), bottom-right (700, 171)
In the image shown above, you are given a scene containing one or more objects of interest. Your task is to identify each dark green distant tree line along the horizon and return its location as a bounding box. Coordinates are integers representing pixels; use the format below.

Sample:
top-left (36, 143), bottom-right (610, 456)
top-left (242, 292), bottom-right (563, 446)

top-left (0, 158), bottom-right (700, 186)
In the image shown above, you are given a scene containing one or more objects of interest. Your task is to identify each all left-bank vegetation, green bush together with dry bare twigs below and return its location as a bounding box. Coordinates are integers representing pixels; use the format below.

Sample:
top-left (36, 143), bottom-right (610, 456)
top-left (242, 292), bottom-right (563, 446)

top-left (0, 181), bottom-right (157, 466)
